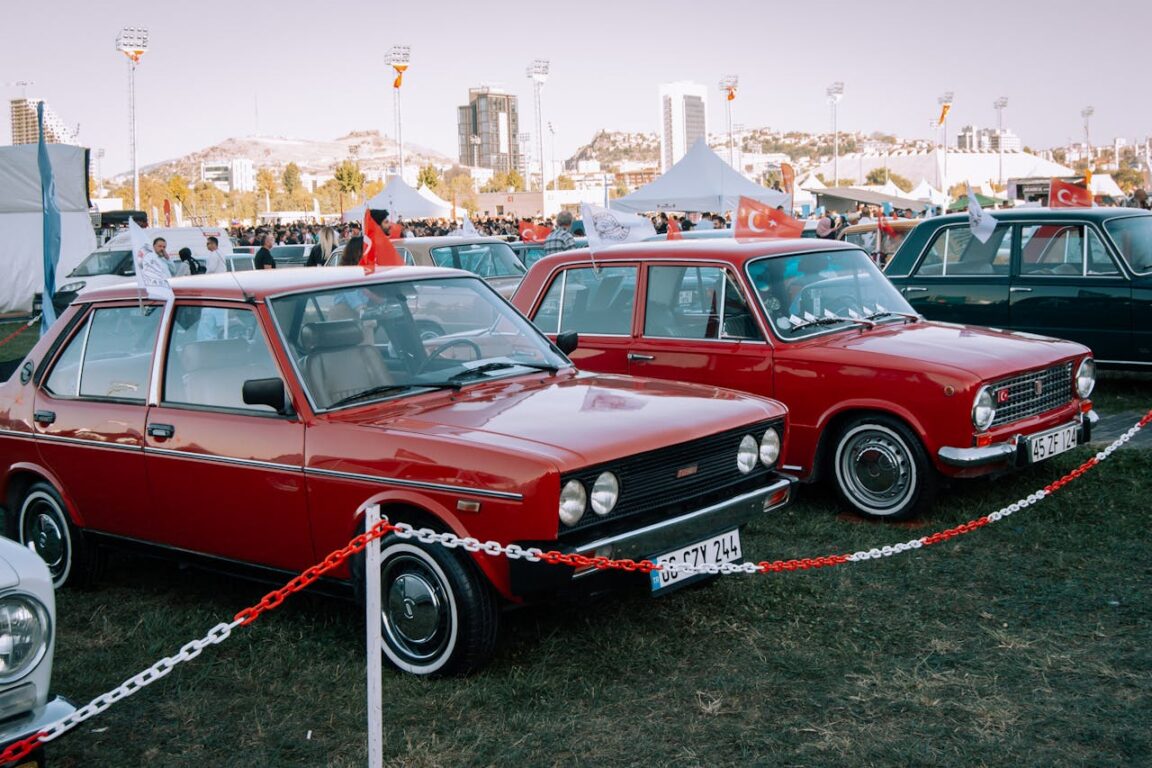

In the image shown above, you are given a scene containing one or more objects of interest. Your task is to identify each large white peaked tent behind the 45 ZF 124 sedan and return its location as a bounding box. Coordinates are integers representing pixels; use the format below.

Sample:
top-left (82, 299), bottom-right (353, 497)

top-left (609, 138), bottom-right (788, 213)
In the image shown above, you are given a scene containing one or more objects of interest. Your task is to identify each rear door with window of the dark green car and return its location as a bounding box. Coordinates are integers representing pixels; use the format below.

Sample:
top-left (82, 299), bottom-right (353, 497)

top-left (900, 223), bottom-right (1013, 327)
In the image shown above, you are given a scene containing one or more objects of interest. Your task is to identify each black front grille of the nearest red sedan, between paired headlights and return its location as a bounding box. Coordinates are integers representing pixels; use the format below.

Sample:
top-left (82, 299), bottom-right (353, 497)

top-left (560, 419), bottom-right (785, 539)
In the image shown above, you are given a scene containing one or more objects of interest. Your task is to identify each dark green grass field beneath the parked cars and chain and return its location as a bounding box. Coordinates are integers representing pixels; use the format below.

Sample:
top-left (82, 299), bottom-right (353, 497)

top-left (0, 326), bottom-right (1152, 767)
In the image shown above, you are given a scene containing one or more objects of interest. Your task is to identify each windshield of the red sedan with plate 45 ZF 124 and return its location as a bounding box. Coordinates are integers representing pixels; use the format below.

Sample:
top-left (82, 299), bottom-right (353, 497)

top-left (748, 249), bottom-right (916, 340)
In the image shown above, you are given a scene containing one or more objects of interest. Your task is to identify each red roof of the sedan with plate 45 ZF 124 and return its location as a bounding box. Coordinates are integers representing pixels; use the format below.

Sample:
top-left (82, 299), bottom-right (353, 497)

top-left (530, 237), bottom-right (859, 269)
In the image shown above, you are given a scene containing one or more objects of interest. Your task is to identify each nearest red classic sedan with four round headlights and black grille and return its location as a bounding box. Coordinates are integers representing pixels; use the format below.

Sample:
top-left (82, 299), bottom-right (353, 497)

top-left (0, 267), bottom-right (793, 675)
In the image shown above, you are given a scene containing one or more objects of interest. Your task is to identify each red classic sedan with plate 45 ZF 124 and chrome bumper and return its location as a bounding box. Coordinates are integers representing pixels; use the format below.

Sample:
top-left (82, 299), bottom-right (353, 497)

top-left (513, 239), bottom-right (1097, 518)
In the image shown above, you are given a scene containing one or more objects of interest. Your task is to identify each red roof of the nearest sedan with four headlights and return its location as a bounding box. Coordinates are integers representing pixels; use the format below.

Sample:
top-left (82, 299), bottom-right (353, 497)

top-left (81, 266), bottom-right (477, 302)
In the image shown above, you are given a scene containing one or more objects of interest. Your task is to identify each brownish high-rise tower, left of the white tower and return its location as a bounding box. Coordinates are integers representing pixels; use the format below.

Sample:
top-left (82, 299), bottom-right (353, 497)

top-left (456, 85), bottom-right (524, 173)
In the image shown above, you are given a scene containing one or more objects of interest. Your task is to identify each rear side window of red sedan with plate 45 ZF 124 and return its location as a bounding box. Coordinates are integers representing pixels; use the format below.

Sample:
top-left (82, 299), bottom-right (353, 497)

top-left (532, 267), bottom-right (636, 336)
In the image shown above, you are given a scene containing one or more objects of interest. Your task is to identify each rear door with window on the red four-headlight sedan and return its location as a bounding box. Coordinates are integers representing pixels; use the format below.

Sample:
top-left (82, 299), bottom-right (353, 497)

top-left (35, 302), bottom-right (162, 538)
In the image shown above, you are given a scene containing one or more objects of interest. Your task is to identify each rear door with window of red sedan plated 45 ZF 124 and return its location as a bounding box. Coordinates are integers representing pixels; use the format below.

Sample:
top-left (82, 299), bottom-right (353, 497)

top-left (531, 263), bottom-right (639, 373)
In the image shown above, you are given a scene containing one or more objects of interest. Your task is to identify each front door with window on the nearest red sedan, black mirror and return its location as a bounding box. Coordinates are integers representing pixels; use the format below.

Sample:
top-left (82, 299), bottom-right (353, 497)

top-left (145, 303), bottom-right (314, 570)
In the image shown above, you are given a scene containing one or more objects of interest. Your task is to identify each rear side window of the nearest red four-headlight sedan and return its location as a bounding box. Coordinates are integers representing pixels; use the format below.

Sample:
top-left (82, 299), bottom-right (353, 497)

top-left (45, 305), bottom-right (161, 403)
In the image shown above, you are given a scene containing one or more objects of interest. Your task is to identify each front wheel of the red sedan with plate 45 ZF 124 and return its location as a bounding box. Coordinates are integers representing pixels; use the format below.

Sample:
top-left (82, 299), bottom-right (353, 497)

top-left (832, 413), bottom-right (940, 520)
